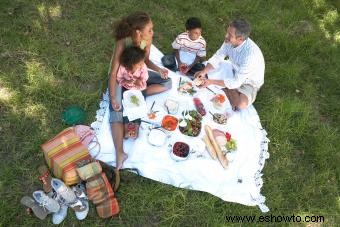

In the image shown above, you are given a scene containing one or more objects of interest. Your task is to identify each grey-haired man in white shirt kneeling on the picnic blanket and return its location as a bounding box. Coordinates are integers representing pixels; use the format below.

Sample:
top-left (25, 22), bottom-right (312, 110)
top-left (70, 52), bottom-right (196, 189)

top-left (195, 19), bottom-right (265, 109)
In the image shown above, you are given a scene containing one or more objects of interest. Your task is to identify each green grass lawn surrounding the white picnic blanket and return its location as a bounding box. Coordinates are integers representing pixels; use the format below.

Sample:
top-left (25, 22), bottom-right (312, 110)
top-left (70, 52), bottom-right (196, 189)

top-left (0, 0), bottom-right (340, 226)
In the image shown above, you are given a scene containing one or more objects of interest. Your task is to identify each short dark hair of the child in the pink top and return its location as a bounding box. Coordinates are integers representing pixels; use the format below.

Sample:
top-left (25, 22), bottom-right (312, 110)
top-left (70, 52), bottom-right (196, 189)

top-left (120, 46), bottom-right (145, 70)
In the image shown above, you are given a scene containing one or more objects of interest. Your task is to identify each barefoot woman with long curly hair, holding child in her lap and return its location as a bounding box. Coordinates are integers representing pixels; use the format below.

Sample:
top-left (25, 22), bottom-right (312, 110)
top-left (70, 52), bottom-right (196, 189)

top-left (109, 12), bottom-right (172, 176)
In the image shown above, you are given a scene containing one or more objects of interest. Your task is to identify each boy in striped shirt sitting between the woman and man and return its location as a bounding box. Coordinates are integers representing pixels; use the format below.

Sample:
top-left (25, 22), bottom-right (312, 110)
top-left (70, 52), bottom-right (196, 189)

top-left (162, 17), bottom-right (206, 77)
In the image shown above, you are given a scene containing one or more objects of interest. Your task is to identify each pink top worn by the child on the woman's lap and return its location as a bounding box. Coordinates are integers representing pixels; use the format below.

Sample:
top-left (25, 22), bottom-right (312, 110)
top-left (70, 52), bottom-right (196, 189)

top-left (117, 64), bottom-right (149, 90)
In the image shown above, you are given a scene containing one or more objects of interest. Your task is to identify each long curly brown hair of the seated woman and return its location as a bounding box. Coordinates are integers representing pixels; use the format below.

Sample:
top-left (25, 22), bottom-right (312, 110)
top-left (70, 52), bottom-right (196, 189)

top-left (114, 11), bottom-right (151, 40)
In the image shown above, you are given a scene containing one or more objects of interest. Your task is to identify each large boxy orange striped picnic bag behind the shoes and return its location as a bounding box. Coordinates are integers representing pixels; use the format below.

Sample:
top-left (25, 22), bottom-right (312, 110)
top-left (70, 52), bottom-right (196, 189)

top-left (41, 127), bottom-right (91, 185)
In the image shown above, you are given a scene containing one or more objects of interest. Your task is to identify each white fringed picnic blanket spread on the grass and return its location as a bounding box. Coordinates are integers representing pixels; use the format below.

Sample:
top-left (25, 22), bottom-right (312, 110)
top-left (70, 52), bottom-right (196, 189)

top-left (91, 46), bottom-right (269, 212)
